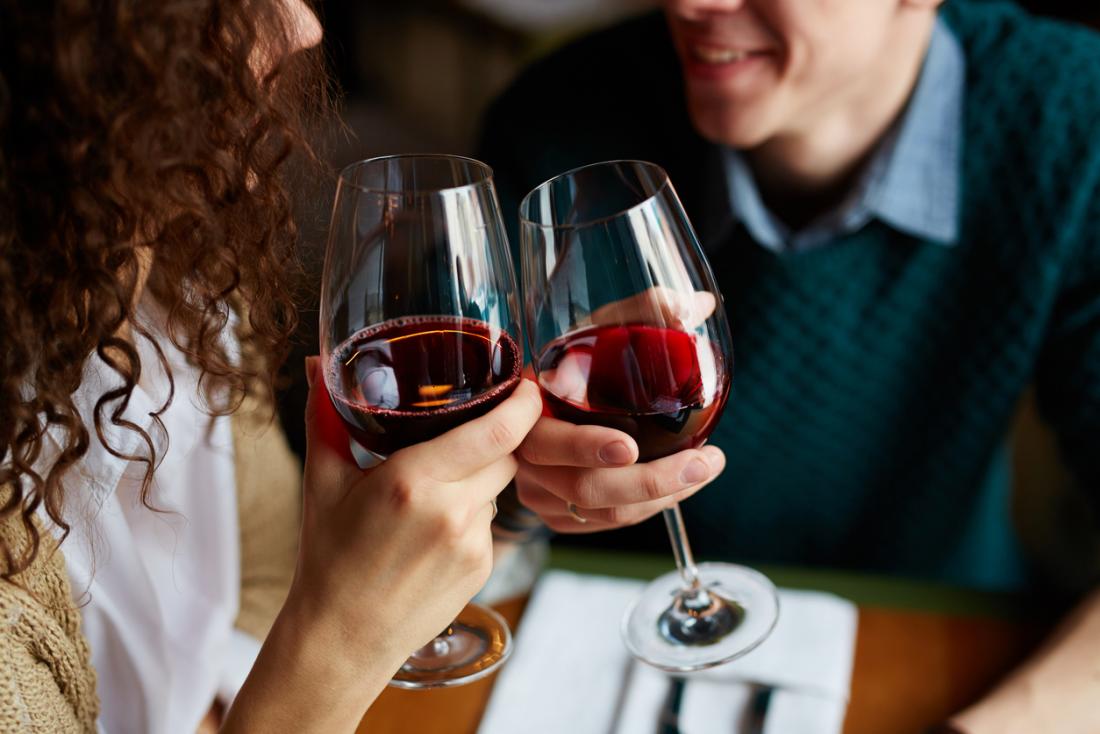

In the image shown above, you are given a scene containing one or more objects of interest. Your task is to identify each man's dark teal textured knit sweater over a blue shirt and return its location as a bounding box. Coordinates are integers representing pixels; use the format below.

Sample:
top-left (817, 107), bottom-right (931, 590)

top-left (482, 0), bottom-right (1100, 589)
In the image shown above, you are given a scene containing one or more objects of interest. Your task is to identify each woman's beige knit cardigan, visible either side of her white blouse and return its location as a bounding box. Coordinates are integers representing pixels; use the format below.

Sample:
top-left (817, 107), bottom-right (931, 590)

top-left (0, 393), bottom-right (301, 734)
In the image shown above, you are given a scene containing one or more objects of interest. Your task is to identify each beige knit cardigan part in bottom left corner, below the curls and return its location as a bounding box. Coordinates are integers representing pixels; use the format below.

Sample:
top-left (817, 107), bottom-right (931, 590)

top-left (0, 499), bottom-right (99, 733)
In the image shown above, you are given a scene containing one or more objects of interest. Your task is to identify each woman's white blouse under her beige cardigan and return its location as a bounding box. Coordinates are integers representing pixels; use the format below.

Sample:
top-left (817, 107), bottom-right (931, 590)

top-left (38, 304), bottom-right (260, 734)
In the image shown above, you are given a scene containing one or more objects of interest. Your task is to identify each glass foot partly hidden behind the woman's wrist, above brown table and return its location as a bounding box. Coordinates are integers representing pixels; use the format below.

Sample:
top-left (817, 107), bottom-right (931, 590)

top-left (389, 604), bottom-right (512, 689)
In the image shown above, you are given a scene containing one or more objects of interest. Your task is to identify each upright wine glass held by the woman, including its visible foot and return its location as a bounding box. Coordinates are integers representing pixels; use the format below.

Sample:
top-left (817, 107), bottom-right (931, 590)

top-left (320, 155), bottom-right (523, 689)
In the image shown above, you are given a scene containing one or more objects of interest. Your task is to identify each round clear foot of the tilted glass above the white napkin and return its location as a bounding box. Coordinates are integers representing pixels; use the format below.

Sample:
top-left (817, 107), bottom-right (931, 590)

top-left (623, 563), bottom-right (779, 672)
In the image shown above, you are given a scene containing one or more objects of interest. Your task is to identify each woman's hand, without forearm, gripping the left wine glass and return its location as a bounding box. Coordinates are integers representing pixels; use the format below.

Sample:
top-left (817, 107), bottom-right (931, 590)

top-left (290, 360), bottom-right (541, 660)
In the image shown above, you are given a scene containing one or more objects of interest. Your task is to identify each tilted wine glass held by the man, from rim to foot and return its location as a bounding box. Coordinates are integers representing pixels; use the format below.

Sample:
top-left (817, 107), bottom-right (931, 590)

top-left (519, 161), bottom-right (779, 672)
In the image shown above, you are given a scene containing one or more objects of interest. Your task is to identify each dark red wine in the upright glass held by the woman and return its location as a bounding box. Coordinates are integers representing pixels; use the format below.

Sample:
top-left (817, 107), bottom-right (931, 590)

top-left (327, 316), bottom-right (523, 457)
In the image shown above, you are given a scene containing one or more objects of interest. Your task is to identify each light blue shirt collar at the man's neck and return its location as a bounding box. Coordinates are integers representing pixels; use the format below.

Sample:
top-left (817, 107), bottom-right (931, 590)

top-left (723, 19), bottom-right (966, 252)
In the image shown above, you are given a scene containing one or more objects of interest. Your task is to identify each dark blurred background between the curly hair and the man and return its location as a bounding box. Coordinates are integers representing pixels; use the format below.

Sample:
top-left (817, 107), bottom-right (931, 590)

top-left (279, 0), bottom-right (1100, 453)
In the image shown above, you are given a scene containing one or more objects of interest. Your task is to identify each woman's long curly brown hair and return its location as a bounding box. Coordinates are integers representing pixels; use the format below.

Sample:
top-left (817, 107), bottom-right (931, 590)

top-left (0, 0), bottom-right (327, 580)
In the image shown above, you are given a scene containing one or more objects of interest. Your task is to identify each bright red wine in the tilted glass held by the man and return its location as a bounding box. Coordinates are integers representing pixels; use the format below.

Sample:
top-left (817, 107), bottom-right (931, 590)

top-left (537, 324), bottom-right (729, 461)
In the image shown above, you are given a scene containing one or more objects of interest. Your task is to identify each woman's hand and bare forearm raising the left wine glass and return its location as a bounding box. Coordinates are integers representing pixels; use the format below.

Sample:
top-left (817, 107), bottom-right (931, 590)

top-left (223, 358), bottom-right (541, 732)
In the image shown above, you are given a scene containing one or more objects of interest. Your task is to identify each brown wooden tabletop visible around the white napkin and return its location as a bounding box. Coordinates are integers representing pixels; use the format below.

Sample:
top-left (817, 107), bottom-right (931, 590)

top-left (359, 551), bottom-right (1051, 734)
